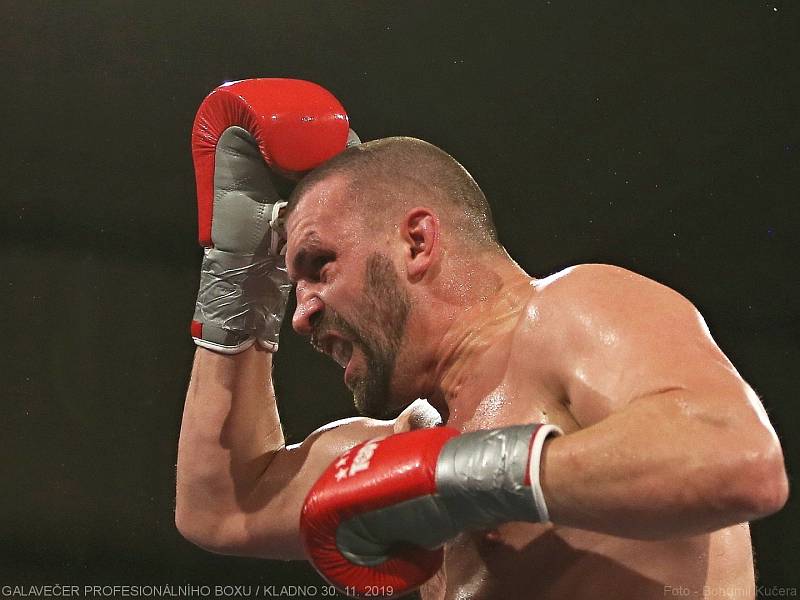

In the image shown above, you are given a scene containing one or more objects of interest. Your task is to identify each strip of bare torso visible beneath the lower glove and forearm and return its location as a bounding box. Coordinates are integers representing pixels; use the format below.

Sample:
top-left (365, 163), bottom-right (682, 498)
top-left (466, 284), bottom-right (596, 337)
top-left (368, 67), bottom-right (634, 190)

top-left (420, 523), bottom-right (754, 600)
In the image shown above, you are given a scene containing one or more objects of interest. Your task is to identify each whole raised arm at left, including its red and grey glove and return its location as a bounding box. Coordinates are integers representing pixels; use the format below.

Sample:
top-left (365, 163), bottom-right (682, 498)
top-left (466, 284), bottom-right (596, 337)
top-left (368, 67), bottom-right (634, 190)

top-left (175, 79), bottom-right (392, 558)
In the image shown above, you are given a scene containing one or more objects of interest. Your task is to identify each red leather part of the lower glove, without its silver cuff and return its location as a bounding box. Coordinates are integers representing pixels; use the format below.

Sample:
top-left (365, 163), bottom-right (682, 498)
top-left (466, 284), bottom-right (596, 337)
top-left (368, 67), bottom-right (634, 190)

top-left (300, 427), bottom-right (458, 597)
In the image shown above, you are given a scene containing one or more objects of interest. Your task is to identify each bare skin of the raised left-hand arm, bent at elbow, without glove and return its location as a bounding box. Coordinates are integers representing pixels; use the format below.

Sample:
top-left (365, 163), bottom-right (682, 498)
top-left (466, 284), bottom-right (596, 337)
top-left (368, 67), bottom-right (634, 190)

top-left (175, 346), bottom-right (393, 559)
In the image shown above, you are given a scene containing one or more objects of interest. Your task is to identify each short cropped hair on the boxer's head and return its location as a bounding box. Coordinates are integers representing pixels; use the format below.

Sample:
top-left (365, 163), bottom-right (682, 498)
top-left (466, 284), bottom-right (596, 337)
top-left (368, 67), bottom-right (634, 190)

top-left (286, 137), bottom-right (500, 249)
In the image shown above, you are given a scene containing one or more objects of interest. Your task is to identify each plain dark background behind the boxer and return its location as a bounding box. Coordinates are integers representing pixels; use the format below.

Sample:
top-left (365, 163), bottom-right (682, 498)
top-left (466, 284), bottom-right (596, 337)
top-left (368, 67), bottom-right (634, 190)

top-left (0, 0), bottom-right (800, 586)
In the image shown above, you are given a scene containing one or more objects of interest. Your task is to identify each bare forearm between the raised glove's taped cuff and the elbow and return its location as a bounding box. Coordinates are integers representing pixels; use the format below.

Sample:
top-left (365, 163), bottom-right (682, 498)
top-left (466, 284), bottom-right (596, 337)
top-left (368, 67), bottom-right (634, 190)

top-left (176, 346), bottom-right (284, 531)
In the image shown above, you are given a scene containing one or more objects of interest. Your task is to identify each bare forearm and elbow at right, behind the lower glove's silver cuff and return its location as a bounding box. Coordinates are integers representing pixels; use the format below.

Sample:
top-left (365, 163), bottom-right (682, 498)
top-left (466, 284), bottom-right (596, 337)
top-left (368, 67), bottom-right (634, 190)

top-left (542, 392), bottom-right (785, 539)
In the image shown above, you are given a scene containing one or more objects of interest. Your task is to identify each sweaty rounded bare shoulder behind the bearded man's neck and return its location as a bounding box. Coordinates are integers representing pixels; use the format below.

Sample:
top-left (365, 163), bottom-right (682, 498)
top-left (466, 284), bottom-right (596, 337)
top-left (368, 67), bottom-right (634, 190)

top-left (527, 264), bottom-right (725, 425)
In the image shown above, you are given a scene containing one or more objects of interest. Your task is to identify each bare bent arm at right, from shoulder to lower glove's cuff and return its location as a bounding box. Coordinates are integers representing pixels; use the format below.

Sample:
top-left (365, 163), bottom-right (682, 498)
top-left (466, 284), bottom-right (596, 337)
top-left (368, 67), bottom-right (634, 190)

top-left (541, 265), bottom-right (788, 539)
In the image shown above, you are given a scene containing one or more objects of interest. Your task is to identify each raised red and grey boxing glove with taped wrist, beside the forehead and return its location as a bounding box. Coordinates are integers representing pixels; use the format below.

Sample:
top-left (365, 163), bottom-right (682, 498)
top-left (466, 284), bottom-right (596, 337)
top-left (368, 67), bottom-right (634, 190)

top-left (192, 79), bottom-right (349, 354)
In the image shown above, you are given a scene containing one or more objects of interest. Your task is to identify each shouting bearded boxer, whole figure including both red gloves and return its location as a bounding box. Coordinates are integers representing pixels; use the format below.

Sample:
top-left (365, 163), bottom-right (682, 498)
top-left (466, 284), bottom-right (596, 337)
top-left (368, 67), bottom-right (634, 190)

top-left (176, 82), bottom-right (788, 600)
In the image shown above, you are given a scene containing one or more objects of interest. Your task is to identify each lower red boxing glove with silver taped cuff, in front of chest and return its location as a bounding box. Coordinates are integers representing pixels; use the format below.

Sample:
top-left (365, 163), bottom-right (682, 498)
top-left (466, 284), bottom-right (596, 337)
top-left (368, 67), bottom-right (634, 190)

top-left (300, 424), bottom-right (561, 597)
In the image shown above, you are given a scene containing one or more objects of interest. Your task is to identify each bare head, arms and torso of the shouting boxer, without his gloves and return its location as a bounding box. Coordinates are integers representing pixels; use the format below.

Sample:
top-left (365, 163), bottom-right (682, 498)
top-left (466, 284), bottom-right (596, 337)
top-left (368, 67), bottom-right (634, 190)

top-left (176, 81), bottom-right (788, 600)
